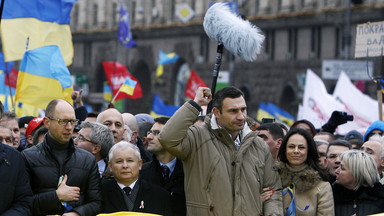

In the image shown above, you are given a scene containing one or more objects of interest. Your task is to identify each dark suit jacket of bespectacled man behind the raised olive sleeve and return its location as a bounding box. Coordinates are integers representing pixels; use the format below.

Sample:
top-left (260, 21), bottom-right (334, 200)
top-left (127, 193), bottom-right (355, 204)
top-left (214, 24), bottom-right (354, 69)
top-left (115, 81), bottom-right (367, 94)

top-left (140, 156), bottom-right (186, 216)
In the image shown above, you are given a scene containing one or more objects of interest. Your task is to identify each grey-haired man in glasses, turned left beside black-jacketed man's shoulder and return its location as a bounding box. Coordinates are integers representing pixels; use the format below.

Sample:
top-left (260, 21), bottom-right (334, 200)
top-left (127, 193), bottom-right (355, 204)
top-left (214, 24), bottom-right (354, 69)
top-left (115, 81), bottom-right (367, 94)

top-left (74, 122), bottom-right (113, 177)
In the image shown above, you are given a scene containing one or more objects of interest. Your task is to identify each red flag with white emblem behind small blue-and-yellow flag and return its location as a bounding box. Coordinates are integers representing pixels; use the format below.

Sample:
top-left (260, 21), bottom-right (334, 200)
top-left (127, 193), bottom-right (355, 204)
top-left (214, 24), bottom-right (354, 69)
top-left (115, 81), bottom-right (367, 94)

top-left (102, 61), bottom-right (143, 101)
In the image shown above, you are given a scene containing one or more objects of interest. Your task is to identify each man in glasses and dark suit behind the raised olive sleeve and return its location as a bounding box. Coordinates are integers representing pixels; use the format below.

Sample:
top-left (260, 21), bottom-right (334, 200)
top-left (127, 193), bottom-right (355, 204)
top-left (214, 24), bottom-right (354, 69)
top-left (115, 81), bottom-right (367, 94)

top-left (140, 117), bottom-right (186, 216)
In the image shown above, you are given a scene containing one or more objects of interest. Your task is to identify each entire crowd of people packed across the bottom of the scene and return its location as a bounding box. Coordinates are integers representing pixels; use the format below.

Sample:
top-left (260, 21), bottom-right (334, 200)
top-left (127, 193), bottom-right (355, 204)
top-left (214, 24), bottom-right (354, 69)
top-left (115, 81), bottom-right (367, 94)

top-left (0, 87), bottom-right (384, 216)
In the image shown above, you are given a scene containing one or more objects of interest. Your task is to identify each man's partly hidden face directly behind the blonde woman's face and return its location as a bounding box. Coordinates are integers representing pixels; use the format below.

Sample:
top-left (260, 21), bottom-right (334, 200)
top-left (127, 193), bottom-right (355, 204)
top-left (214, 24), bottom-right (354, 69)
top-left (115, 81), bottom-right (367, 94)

top-left (326, 140), bottom-right (352, 184)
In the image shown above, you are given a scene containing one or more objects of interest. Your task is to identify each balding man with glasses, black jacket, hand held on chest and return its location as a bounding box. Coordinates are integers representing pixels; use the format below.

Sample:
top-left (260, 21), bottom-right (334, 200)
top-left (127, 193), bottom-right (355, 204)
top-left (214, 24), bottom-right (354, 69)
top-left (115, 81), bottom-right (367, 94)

top-left (22, 99), bottom-right (102, 216)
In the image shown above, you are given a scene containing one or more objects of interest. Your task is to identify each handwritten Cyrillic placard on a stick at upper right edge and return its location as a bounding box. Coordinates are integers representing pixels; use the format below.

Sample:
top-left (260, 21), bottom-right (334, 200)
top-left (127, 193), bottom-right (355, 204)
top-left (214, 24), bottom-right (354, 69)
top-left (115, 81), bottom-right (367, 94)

top-left (355, 22), bottom-right (384, 58)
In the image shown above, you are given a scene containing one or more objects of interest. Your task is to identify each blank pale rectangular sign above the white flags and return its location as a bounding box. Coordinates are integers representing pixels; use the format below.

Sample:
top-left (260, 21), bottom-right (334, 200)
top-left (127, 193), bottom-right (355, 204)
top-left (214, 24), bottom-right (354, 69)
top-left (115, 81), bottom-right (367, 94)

top-left (321, 60), bottom-right (373, 80)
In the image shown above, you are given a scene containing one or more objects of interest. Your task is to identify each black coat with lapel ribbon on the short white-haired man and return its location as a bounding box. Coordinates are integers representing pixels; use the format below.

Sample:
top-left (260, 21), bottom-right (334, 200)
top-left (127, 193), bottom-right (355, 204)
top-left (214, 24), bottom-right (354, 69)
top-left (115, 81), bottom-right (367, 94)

top-left (102, 178), bottom-right (173, 216)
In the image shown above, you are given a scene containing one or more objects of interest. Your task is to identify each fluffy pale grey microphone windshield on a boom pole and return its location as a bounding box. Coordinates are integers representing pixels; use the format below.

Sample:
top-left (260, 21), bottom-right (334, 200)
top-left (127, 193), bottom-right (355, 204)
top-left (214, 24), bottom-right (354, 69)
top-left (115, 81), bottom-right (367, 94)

top-left (203, 3), bottom-right (265, 61)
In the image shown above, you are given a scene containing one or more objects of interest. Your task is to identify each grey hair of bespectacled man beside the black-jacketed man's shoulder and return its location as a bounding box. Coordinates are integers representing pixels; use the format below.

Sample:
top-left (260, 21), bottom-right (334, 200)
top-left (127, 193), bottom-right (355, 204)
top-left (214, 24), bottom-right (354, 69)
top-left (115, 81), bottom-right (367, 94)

top-left (80, 122), bottom-right (113, 159)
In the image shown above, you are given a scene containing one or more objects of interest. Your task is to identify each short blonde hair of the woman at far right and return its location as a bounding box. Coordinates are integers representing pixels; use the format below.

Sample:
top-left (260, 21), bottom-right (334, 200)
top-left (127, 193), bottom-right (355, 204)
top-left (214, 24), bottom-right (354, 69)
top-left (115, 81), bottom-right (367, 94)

top-left (340, 150), bottom-right (380, 190)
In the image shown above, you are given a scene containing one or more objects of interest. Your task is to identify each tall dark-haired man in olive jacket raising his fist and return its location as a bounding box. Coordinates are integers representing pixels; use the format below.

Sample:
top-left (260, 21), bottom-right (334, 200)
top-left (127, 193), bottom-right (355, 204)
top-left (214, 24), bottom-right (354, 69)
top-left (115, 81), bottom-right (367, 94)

top-left (159, 87), bottom-right (283, 216)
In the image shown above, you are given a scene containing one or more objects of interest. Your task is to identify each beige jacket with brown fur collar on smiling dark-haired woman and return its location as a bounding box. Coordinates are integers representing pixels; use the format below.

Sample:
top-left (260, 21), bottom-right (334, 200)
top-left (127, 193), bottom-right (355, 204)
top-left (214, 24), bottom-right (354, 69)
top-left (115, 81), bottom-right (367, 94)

top-left (278, 162), bottom-right (335, 216)
